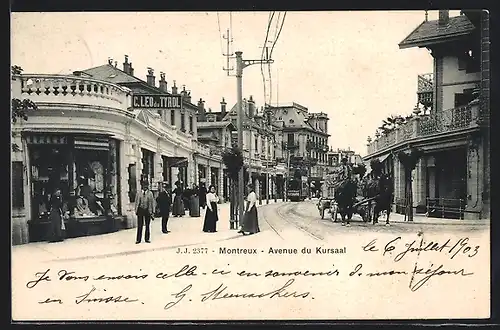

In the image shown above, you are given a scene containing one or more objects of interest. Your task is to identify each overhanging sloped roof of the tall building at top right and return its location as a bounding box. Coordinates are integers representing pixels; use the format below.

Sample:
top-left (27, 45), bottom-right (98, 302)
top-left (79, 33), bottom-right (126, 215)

top-left (399, 15), bottom-right (475, 49)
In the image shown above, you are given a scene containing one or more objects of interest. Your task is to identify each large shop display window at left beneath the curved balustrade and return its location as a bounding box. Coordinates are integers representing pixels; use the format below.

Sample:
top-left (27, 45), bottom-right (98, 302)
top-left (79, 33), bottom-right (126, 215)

top-left (28, 136), bottom-right (120, 219)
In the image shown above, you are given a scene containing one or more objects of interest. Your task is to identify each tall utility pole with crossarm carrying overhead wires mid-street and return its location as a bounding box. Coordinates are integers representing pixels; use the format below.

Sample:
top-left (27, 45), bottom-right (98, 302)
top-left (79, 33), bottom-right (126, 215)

top-left (235, 51), bottom-right (274, 225)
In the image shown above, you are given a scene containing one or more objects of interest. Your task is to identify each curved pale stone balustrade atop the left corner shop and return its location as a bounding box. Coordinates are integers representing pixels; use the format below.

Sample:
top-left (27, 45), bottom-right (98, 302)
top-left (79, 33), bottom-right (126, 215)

top-left (16, 74), bottom-right (130, 110)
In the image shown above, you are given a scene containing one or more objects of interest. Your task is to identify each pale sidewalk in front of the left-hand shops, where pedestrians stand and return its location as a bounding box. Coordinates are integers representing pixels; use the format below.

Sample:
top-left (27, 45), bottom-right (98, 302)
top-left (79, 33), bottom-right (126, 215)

top-left (12, 200), bottom-right (280, 261)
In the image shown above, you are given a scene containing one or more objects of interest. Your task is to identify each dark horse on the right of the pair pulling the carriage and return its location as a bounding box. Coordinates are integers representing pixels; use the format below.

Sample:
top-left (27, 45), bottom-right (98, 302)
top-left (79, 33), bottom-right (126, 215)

top-left (364, 173), bottom-right (393, 226)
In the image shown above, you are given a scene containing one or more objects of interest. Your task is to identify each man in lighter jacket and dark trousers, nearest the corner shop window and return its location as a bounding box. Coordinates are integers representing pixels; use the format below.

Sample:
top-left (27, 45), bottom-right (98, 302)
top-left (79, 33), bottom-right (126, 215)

top-left (135, 182), bottom-right (155, 244)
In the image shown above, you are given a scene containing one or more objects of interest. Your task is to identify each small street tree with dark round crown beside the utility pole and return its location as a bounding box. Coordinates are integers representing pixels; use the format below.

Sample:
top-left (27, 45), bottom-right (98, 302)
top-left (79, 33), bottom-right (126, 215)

top-left (222, 146), bottom-right (243, 229)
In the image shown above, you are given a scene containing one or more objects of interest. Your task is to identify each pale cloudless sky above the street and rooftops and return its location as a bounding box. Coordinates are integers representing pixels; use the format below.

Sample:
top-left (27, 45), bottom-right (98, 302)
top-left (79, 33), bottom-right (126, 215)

top-left (11, 10), bottom-right (459, 155)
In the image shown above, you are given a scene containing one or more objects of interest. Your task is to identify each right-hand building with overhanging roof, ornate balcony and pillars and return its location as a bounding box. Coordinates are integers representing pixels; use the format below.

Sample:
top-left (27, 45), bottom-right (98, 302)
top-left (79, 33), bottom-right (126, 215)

top-left (364, 10), bottom-right (490, 219)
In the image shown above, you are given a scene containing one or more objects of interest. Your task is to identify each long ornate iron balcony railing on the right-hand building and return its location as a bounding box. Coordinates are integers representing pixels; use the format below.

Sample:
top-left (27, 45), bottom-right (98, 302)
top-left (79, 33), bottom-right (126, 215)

top-left (368, 101), bottom-right (479, 155)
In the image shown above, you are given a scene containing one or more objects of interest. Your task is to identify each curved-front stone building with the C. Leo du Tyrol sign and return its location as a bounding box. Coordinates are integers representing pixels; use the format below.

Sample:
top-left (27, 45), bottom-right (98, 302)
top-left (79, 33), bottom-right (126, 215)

top-left (11, 57), bottom-right (223, 244)
